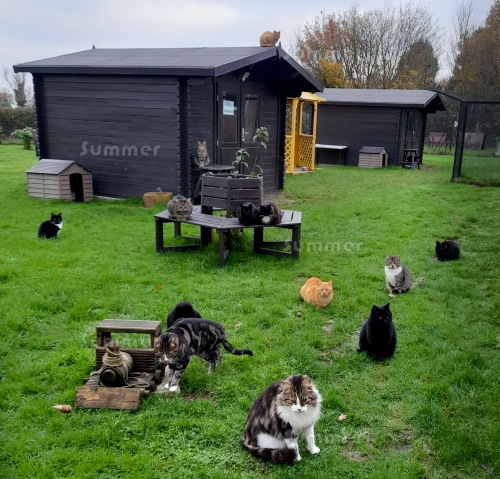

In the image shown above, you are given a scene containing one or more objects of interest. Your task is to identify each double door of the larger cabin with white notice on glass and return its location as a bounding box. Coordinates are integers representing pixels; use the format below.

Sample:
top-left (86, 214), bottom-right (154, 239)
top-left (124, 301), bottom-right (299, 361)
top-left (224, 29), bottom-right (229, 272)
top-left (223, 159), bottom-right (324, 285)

top-left (217, 81), bottom-right (260, 173)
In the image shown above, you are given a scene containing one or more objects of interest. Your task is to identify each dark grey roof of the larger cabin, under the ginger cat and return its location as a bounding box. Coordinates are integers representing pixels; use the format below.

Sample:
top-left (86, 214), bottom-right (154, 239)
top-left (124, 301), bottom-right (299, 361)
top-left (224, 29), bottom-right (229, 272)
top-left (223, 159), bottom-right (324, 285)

top-left (14, 46), bottom-right (323, 91)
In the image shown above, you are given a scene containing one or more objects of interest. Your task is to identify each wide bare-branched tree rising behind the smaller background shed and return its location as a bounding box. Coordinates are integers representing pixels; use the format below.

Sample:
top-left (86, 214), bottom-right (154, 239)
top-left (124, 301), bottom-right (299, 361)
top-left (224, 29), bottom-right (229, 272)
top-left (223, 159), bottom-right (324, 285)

top-left (295, 2), bottom-right (441, 88)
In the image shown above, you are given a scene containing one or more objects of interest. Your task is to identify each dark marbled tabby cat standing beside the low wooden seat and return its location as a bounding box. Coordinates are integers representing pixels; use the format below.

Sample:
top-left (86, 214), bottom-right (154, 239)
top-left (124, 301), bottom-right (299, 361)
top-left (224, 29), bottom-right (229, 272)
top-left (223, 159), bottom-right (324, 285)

top-left (155, 318), bottom-right (253, 392)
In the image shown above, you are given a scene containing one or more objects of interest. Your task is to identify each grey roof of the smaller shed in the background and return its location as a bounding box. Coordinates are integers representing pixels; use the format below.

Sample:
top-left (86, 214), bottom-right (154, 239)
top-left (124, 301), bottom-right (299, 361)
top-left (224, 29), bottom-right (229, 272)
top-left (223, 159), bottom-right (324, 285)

top-left (319, 88), bottom-right (446, 113)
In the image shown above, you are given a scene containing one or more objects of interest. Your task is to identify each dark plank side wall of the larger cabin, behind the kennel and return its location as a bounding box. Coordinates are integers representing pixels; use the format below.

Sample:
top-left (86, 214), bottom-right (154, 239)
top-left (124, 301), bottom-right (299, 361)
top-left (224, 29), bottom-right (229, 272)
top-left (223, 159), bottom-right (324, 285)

top-left (39, 75), bottom-right (180, 197)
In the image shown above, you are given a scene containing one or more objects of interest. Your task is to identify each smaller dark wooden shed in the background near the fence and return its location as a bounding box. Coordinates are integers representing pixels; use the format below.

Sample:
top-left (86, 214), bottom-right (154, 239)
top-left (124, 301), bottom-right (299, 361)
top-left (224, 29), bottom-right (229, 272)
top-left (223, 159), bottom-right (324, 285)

top-left (316, 88), bottom-right (445, 166)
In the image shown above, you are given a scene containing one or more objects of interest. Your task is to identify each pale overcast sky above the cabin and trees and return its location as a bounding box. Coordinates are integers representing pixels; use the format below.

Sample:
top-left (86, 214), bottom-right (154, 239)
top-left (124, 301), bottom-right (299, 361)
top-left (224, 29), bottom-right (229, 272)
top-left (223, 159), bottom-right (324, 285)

top-left (0, 0), bottom-right (494, 95)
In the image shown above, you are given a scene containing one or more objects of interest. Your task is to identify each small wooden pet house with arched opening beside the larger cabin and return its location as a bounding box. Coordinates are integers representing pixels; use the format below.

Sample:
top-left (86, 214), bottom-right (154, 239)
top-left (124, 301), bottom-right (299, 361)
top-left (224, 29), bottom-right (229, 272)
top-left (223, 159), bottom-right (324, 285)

top-left (26, 159), bottom-right (94, 201)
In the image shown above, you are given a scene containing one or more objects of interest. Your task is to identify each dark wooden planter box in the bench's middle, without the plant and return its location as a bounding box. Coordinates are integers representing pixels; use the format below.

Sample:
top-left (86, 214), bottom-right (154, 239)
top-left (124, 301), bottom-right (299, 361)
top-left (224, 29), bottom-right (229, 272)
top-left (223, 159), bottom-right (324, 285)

top-left (201, 174), bottom-right (263, 217)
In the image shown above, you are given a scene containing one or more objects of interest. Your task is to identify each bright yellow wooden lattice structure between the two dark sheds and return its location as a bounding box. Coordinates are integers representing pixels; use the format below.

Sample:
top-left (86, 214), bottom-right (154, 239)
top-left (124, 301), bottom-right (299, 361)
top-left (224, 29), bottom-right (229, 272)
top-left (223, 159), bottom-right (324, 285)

top-left (285, 92), bottom-right (324, 173)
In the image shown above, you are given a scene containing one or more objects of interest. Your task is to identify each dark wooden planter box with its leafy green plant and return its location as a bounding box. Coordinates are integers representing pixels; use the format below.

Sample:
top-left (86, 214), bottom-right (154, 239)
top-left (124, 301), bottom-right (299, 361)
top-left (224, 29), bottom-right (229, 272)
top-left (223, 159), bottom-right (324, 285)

top-left (201, 126), bottom-right (269, 216)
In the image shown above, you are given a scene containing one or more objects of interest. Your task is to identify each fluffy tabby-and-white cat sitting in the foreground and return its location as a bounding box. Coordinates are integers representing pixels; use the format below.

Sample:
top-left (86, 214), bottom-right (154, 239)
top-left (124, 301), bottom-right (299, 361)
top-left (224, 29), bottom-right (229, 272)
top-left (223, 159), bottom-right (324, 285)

top-left (241, 374), bottom-right (322, 464)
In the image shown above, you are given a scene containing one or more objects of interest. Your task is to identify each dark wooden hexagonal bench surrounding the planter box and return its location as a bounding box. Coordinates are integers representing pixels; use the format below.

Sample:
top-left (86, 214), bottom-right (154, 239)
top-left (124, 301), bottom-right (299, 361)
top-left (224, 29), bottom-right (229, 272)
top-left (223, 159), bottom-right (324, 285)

top-left (154, 206), bottom-right (302, 268)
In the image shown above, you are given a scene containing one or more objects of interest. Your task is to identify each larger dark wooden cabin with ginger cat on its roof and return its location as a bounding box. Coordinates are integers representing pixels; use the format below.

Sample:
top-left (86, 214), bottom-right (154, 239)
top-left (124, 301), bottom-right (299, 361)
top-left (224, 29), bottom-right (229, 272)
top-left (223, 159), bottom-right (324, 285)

top-left (14, 46), bottom-right (323, 197)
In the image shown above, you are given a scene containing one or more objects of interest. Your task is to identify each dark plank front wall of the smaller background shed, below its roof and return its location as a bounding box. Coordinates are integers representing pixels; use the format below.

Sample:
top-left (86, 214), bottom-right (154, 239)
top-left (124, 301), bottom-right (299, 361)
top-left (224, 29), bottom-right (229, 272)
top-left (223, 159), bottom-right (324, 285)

top-left (316, 103), bottom-right (402, 166)
